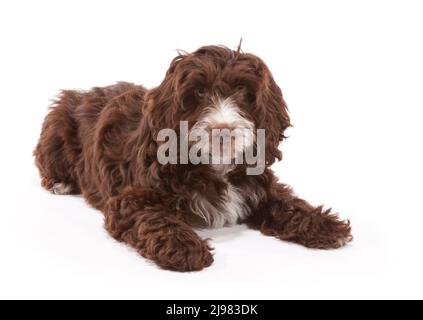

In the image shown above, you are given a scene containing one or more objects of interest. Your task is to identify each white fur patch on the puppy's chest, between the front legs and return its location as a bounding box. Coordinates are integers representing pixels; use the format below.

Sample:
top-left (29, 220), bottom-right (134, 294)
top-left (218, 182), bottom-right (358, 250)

top-left (190, 183), bottom-right (250, 228)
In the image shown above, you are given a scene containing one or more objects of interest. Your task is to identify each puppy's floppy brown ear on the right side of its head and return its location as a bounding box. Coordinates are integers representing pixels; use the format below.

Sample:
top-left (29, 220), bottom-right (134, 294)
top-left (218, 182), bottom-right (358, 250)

top-left (256, 60), bottom-right (291, 165)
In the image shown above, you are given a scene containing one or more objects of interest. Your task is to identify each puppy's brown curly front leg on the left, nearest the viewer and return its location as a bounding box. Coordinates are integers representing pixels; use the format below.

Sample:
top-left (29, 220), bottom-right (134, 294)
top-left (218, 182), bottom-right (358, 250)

top-left (105, 191), bottom-right (213, 271)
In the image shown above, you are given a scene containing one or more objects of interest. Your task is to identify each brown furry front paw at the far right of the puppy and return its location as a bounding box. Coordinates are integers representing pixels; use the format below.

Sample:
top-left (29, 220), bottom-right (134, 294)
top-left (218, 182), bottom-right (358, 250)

top-left (303, 212), bottom-right (353, 249)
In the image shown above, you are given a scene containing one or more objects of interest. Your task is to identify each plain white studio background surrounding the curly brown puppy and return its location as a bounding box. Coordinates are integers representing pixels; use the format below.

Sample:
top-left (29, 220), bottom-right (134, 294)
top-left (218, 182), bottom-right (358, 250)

top-left (0, 0), bottom-right (423, 299)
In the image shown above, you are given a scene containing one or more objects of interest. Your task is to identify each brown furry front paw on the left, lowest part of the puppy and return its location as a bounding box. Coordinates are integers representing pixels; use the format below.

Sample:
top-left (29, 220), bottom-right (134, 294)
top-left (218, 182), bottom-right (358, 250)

top-left (154, 233), bottom-right (213, 272)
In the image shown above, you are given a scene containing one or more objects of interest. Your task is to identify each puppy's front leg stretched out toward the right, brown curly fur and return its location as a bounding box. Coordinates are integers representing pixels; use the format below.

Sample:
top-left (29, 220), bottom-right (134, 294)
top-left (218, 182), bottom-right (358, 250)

top-left (246, 183), bottom-right (352, 249)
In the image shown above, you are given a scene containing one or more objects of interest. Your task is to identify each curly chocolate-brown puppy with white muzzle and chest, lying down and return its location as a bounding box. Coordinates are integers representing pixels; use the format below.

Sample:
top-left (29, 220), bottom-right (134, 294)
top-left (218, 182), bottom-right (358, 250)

top-left (35, 46), bottom-right (352, 271)
